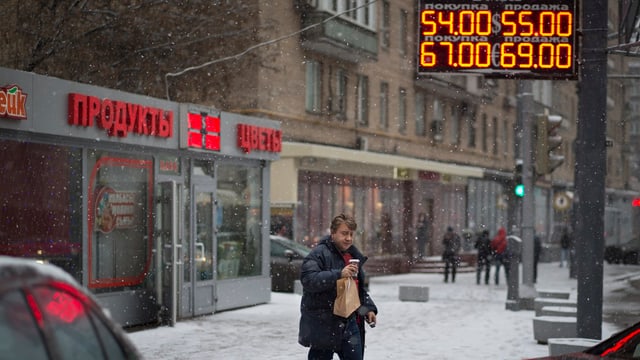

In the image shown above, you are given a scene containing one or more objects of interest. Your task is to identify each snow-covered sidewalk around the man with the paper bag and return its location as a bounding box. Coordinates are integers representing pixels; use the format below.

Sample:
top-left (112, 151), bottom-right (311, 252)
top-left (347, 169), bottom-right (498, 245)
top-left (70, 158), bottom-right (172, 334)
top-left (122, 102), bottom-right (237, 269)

top-left (130, 263), bottom-right (637, 360)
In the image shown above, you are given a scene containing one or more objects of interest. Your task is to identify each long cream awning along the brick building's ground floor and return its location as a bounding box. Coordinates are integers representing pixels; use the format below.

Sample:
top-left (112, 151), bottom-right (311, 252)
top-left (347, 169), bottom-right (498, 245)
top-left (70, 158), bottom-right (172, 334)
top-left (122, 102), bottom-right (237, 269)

top-left (280, 142), bottom-right (484, 178)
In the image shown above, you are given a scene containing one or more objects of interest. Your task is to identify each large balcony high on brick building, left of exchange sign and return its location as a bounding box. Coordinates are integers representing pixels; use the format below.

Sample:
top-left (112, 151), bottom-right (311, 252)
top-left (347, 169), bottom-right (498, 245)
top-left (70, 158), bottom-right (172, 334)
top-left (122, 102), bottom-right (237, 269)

top-left (302, 9), bottom-right (378, 63)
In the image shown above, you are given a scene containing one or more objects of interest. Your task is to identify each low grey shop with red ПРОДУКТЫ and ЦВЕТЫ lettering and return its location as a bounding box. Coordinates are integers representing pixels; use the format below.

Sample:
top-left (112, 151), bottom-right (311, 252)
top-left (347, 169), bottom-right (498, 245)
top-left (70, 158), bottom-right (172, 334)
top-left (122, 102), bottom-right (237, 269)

top-left (0, 68), bottom-right (281, 326)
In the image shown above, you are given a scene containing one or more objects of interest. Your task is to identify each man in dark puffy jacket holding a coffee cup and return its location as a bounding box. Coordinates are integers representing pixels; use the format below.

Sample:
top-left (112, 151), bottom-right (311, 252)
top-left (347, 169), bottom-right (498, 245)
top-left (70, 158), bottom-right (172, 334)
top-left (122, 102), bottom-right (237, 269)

top-left (298, 214), bottom-right (378, 360)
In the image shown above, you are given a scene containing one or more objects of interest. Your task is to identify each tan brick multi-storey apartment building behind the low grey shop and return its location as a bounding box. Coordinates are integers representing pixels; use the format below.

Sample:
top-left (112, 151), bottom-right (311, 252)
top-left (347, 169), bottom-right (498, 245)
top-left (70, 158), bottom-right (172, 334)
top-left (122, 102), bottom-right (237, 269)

top-left (0, 0), bottom-right (639, 282)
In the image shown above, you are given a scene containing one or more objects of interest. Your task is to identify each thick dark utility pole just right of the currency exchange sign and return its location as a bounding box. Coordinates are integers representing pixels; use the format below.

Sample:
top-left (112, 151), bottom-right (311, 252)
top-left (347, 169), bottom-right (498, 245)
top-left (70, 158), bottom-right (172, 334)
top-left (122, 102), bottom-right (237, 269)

top-left (573, 0), bottom-right (608, 339)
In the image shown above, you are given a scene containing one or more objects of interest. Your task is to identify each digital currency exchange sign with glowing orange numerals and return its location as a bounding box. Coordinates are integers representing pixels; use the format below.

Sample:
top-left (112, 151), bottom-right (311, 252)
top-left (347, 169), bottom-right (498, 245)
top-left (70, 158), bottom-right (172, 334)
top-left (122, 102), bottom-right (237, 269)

top-left (417, 0), bottom-right (579, 79)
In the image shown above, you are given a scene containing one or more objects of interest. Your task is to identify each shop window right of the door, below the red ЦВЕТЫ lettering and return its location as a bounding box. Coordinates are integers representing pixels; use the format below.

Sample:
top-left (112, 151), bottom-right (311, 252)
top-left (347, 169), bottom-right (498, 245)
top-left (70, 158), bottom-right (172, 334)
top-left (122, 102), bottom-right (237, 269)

top-left (216, 164), bottom-right (263, 279)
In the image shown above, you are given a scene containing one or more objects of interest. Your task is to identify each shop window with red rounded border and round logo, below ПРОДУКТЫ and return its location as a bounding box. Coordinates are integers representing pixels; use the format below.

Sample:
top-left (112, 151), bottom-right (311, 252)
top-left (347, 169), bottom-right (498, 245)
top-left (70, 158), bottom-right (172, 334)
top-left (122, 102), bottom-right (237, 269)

top-left (87, 152), bottom-right (153, 288)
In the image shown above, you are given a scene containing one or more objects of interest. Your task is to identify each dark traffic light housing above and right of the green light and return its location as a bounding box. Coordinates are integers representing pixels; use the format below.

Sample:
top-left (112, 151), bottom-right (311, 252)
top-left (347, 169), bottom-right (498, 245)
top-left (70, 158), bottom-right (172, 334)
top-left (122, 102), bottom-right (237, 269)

top-left (533, 114), bottom-right (564, 175)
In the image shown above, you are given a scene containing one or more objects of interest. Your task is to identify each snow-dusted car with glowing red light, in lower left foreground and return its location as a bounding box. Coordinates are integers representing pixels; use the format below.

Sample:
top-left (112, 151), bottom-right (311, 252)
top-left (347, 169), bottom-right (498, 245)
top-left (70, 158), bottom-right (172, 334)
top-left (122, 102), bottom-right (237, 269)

top-left (0, 256), bottom-right (141, 360)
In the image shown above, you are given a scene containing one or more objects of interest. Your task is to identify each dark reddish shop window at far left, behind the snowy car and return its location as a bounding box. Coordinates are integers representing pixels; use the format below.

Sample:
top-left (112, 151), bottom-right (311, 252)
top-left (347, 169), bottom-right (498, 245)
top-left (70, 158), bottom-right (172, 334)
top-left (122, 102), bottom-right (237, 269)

top-left (0, 140), bottom-right (82, 281)
